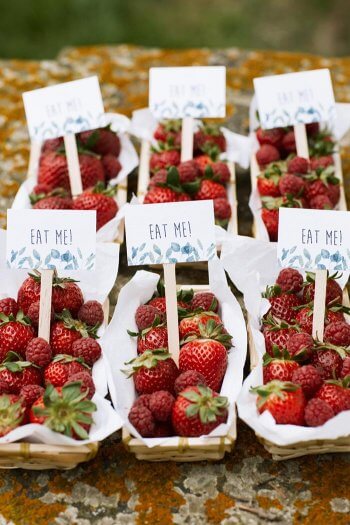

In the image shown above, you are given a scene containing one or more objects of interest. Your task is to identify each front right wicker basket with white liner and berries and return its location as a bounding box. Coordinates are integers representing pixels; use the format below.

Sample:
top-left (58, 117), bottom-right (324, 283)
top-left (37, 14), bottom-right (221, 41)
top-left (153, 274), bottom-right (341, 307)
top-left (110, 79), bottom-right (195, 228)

top-left (222, 237), bottom-right (350, 460)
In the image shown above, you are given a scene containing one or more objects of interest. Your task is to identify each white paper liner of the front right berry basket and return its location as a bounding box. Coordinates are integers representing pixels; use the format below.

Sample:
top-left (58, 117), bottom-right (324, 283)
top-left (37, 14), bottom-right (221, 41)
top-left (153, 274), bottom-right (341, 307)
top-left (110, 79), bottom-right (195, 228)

top-left (221, 235), bottom-right (350, 446)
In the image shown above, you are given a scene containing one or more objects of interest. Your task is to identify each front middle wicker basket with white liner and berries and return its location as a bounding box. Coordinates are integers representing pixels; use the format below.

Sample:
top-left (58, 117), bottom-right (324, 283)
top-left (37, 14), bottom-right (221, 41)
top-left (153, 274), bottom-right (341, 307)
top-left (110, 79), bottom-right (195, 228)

top-left (104, 260), bottom-right (246, 462)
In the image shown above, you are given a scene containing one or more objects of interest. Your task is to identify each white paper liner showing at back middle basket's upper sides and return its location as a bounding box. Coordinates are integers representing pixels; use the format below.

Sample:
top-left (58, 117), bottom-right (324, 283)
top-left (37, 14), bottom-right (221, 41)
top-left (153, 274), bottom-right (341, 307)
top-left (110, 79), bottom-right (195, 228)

top-left (130, 108), bottom-right (253, 169)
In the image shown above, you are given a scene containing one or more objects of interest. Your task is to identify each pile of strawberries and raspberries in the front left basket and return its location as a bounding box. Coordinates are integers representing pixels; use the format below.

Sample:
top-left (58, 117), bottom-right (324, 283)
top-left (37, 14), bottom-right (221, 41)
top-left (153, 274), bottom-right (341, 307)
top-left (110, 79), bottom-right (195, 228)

top-left (0, 272), bottom-right (103, 439)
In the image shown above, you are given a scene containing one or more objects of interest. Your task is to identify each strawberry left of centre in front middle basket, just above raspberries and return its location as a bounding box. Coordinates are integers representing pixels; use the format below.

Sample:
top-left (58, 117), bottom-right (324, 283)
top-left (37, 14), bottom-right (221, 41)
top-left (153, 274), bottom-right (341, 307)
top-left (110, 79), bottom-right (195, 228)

top-left (126, 349), bottom-right (179, 394)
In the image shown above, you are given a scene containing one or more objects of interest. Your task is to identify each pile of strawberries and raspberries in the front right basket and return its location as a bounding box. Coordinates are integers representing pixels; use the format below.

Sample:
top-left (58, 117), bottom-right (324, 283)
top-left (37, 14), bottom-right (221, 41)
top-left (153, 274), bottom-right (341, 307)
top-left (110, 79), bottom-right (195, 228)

top-left (252, 268), bottom-right (350, 427)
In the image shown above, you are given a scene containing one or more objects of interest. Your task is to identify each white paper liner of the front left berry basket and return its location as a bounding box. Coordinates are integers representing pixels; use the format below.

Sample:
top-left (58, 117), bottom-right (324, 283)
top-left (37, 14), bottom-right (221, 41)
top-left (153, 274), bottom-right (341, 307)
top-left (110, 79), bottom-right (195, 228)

top-left (0, 230), bottom-right (121, 446)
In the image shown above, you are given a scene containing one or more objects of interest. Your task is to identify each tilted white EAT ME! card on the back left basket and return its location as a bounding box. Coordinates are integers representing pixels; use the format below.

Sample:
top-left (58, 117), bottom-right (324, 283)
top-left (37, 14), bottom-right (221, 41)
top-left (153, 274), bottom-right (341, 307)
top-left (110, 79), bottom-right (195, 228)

top-left (23, 76), bottom-right (104, 141)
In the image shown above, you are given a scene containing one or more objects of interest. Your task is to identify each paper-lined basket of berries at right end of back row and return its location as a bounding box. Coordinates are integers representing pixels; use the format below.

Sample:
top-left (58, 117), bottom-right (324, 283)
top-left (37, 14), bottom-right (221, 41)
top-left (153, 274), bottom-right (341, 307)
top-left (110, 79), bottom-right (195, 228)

top-left (249, 97), bottom-right (349, 241)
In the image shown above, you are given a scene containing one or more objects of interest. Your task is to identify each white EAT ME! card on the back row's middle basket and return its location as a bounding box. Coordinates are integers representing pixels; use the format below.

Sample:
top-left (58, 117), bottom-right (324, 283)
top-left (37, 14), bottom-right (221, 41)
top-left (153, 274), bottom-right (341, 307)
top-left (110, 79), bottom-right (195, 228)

top-left (149, 66), bottom-right (226, 119)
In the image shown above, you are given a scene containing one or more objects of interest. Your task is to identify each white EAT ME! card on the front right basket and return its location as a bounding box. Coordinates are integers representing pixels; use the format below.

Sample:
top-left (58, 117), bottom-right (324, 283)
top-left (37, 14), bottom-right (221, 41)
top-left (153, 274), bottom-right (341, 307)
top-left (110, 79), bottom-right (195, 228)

top-left (277, 208), bottom-right (350, 271)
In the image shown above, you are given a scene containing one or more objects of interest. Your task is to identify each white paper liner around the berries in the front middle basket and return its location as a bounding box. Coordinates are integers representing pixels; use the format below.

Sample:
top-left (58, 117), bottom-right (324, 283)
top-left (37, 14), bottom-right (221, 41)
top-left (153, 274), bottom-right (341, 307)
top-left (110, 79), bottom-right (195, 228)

top-left (103, 260), bottom-right (247, 447)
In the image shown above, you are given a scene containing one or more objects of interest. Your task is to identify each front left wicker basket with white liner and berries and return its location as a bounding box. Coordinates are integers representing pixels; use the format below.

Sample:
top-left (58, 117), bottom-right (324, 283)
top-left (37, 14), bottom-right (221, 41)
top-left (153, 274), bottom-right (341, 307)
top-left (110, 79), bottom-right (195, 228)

top-left (0, 231), bottom-right (121, 470)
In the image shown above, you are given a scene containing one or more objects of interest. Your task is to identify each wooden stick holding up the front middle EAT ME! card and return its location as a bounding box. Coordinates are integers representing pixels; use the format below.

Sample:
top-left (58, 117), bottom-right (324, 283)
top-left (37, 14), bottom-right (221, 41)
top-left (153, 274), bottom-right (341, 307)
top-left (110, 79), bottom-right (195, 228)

top-left (163, 263), bottom-right (180, 365)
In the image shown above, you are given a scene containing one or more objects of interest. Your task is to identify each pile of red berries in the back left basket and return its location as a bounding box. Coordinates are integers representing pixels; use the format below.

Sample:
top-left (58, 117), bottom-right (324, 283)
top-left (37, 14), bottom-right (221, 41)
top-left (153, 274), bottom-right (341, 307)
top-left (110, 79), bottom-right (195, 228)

top-left (30, 127), bottom-right (122, 229)
